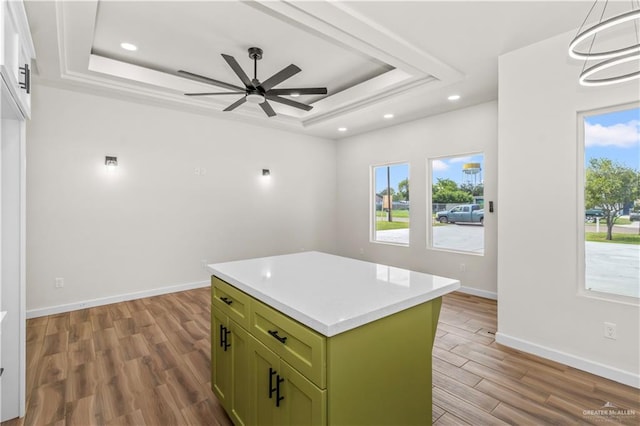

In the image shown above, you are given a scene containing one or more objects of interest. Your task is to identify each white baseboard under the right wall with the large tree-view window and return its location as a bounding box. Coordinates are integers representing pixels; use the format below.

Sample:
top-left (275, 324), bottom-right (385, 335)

top-left (496, 332), bottom-right (640, 389)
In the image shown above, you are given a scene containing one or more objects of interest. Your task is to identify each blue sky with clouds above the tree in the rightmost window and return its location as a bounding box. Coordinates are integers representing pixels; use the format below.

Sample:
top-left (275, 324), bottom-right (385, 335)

top-left (584, 108), bottom-right (640, 170)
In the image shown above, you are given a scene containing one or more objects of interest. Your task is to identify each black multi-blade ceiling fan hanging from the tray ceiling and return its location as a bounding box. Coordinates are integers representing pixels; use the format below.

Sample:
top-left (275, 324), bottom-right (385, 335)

top-left (178, 47), bottom-right (327, 117)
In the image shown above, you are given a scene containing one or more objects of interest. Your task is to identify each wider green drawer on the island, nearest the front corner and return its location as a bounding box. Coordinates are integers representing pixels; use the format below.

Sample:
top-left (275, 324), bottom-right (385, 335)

top-left (251, 301), bottom-right (326, 389)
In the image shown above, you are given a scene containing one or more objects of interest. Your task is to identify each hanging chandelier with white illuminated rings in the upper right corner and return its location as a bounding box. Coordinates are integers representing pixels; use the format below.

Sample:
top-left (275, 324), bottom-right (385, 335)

top-left (569, 0), bottom-right (640, 86)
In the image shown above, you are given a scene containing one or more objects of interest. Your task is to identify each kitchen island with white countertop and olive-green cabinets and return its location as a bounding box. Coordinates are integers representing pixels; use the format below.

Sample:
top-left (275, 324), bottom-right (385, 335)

top-left (209, 252), bottom-right (460, 426)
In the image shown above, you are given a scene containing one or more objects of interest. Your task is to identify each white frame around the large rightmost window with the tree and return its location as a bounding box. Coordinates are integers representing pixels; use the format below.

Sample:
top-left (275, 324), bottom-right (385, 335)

top-left (576, 102), bottom-right (640, 306)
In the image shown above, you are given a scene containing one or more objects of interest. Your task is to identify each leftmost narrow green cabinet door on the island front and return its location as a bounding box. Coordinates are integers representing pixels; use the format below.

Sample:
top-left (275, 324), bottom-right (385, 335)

top-left (211, 308), bottom-right (232, 411)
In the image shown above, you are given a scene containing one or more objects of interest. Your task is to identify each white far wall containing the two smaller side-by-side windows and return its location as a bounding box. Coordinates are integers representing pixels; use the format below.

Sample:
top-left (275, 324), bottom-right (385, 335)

top-left (337, 102), bottom-right (499, 297)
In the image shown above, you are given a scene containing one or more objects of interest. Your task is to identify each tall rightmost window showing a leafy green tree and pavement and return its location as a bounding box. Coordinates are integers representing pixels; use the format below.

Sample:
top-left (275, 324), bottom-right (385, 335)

top-left (578, 105), bottom-right (640, 298)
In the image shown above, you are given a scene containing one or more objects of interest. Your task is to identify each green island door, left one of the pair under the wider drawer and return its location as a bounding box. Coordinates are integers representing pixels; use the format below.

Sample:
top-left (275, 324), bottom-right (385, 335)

top-left (249, 336), bottom-right (282, 426)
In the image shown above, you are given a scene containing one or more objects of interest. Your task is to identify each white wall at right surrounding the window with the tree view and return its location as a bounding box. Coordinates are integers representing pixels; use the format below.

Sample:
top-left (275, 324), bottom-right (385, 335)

top-left (498, 32), bottom-right (640, 387)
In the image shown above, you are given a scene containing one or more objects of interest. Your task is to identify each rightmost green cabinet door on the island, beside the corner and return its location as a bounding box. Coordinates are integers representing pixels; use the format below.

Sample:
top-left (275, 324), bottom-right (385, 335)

top-left (279, 360), bottom-right (327, 426)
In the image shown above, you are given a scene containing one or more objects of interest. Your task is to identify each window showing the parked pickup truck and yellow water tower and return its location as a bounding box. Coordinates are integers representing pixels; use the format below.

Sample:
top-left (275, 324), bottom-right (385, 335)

top-left (428, 153), bottom-right (484, 254)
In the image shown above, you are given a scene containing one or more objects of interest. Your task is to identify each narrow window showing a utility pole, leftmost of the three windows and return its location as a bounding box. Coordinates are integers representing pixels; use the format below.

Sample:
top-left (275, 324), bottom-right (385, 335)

top-left (372, 164), bottom-right (409, 245)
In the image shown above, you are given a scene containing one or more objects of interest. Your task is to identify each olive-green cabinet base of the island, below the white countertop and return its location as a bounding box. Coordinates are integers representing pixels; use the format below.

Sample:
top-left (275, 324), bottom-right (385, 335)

top-left (211, 276), bottom-right (442, 426)
